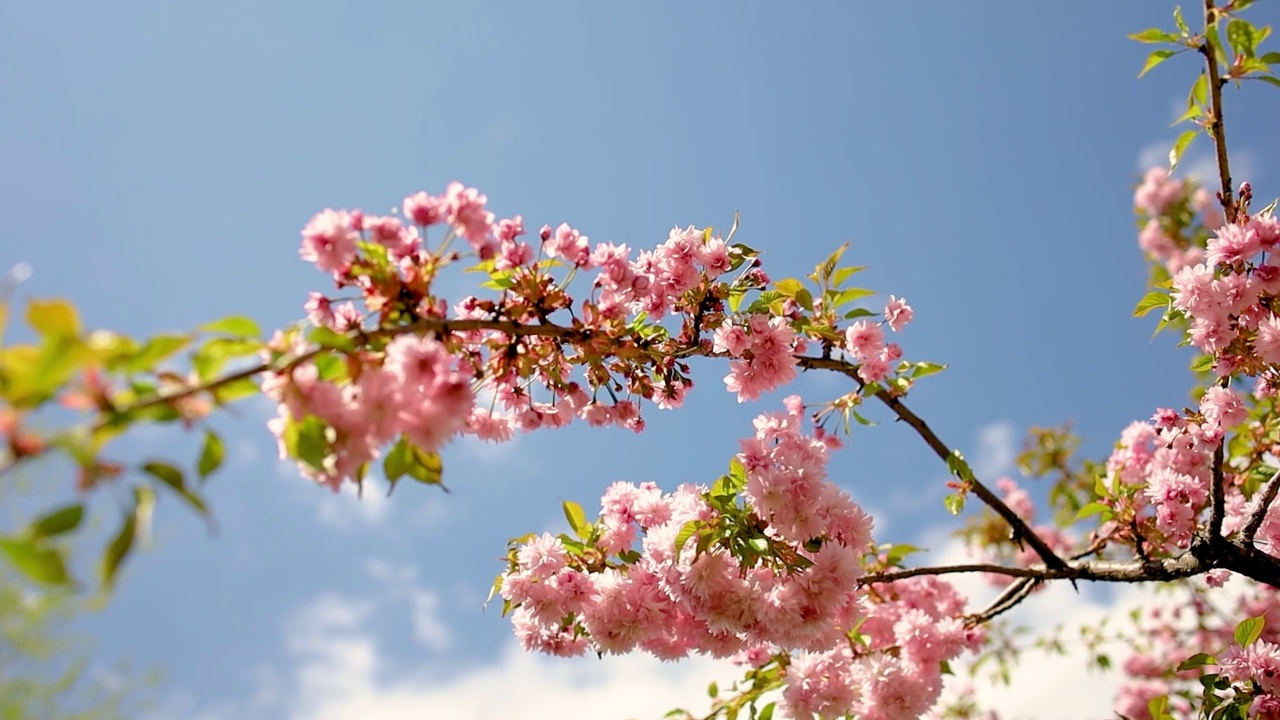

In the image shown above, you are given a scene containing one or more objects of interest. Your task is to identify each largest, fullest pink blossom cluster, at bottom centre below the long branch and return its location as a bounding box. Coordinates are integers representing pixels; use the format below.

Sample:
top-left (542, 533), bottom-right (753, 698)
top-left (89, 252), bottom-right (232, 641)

top-left (500, 397), bottom-right (980, 719)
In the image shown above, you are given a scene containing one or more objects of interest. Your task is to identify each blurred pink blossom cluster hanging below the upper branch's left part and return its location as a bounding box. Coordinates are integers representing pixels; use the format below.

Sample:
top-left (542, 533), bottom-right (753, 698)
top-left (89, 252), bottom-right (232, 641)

top-left (262, 334), bottom-right (475, 491)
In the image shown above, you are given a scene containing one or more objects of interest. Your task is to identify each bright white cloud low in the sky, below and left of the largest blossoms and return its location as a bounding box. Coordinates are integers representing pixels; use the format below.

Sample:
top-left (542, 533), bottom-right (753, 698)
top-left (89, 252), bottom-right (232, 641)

top-left (215, 573), bottom-right (740, 720)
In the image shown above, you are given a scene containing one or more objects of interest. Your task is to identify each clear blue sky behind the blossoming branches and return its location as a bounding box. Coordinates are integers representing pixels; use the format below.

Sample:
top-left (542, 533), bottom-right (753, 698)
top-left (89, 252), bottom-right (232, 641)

top-left (0, 0), bottom-right (1280, 717)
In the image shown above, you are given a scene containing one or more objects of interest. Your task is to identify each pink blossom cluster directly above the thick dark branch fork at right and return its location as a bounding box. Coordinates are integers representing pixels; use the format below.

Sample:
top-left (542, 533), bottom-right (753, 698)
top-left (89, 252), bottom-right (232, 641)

top-left (1100, 386), bottom-right (1248, 550)
